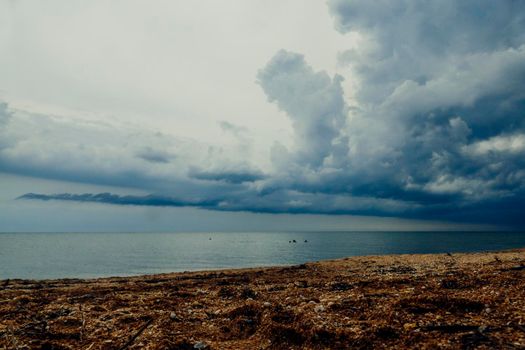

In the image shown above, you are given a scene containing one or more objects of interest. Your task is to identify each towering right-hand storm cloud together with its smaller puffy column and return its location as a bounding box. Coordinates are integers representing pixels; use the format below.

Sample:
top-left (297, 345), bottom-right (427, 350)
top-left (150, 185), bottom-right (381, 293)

top-left (259, 1), bottom-right (525, 224)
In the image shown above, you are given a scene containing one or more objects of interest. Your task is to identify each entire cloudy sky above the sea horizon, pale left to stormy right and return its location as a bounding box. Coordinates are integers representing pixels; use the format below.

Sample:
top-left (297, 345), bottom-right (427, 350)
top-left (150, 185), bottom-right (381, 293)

top-left (0, 0), bottom-right (525, 231)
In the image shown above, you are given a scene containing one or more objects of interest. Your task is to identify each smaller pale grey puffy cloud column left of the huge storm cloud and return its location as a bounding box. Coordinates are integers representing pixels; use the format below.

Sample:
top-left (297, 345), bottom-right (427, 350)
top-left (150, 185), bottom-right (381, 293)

top-left (257, 50), bottom-right (348, 168)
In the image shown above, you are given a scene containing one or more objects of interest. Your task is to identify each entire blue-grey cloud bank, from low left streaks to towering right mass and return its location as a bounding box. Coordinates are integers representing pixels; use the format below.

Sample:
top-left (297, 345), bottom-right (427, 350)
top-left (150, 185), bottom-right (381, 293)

top-left (6, 0), bottom-right (525, 227)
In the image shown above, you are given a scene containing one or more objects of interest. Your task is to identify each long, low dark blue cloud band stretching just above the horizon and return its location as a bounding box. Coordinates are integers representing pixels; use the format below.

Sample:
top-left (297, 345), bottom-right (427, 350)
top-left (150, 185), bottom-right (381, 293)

top-left (17, 187), bottom-right (525, 227)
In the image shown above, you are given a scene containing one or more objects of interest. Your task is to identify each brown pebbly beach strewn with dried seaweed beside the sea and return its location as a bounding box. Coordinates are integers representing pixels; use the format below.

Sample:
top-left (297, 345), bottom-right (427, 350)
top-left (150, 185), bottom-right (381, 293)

top-left (0, 250), bottom-right (525, 350)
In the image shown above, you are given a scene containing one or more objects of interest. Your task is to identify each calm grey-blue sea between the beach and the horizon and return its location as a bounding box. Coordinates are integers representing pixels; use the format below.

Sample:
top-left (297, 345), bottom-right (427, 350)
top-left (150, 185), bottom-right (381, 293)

top-left (0, 232), bottom-right (525, 279)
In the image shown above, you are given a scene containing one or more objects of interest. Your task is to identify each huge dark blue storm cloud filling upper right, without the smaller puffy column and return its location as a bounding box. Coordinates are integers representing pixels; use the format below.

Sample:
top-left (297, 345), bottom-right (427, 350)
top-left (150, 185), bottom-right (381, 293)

top-left (322, 1), bottom-right (525, 224)
